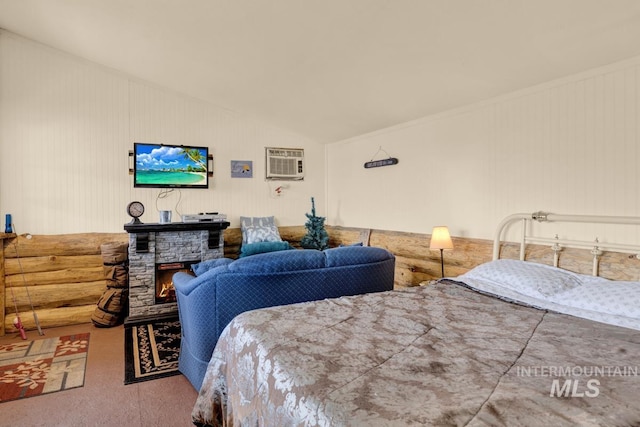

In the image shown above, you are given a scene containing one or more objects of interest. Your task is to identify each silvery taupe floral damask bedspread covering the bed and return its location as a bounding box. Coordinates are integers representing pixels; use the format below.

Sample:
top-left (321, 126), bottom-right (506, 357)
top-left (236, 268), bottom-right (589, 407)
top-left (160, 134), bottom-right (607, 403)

top-left (192, 281), bottom-right (640, 426)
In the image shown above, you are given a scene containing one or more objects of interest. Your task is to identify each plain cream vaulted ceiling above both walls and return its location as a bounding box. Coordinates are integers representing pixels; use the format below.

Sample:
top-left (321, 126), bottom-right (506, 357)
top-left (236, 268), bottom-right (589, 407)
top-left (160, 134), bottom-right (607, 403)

top-left (0, 0), bottom-right (640, 143)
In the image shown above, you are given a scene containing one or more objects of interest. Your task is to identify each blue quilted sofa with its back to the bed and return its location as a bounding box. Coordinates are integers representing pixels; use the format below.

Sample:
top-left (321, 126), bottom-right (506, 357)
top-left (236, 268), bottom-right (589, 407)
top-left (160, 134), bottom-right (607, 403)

top-left (173, 246), bottom-right (395, 390)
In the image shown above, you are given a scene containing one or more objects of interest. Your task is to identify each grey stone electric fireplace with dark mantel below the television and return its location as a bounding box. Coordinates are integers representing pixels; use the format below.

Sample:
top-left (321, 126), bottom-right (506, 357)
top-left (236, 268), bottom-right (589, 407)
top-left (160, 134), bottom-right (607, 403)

top-left (124, 222), bottom-right (229, 322)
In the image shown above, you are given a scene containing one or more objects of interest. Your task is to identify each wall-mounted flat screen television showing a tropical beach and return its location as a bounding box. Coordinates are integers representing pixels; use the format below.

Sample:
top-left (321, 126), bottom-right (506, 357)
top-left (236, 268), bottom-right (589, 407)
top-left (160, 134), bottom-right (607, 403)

top-left (133, 142), bottom-right (209, 188)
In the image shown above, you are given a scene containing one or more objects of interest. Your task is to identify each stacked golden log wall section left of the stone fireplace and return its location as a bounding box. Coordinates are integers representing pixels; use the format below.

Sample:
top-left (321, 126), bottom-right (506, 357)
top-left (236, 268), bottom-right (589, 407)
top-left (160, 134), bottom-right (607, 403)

top-left (0, 233), bottom-right (129, 335)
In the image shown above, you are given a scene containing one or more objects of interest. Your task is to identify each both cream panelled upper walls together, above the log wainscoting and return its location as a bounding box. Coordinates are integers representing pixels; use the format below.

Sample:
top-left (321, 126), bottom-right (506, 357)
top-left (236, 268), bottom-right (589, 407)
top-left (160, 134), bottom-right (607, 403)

top-left (0, 31), bottom-right (640, 243)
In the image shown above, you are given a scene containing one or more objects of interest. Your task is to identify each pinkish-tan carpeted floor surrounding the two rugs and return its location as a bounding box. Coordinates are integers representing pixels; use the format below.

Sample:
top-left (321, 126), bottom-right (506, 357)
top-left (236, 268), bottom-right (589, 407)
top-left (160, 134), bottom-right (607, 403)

top-left (0, 321), bottom-right (198, 427)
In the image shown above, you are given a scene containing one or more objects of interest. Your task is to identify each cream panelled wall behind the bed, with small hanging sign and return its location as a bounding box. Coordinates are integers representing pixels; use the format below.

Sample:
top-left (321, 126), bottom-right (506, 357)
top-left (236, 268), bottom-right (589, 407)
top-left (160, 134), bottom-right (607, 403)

top-left (327, 58), bottom-right (640, 243)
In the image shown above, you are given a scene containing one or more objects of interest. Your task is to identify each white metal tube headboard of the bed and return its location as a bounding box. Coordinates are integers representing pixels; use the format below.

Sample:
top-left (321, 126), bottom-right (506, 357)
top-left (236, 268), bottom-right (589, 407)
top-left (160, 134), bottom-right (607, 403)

top-left (493, 211), bottom-right (640, 276)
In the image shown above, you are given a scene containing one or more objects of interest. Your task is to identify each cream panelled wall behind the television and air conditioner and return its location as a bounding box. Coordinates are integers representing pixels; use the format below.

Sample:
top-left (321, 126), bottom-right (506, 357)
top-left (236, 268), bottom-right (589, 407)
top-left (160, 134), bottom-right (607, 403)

top-left (0, 31), bottom-right (326, 234)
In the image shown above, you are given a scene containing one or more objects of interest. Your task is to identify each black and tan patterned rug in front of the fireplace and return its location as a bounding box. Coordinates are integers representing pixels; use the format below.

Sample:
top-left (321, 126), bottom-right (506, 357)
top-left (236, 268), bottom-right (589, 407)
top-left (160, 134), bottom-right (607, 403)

top-left (124, 320), bottom-right (180, 384)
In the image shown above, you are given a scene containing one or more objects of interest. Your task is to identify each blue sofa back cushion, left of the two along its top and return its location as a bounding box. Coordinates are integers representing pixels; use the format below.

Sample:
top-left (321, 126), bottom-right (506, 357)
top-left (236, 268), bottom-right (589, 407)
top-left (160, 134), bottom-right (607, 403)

top-left (229, 249), bottom-right (325, 274)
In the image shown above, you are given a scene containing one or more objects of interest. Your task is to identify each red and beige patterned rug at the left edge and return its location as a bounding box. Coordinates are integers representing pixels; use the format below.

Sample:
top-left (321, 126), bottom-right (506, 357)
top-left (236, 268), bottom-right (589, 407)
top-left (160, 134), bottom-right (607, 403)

top-left (0, 333), bottom-right (89, 402)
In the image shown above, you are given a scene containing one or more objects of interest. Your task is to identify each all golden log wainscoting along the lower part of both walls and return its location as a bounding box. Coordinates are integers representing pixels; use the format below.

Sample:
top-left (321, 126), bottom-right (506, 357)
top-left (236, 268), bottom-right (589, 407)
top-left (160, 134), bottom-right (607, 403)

top-left (0, 226), bottom-right (640, 336)
